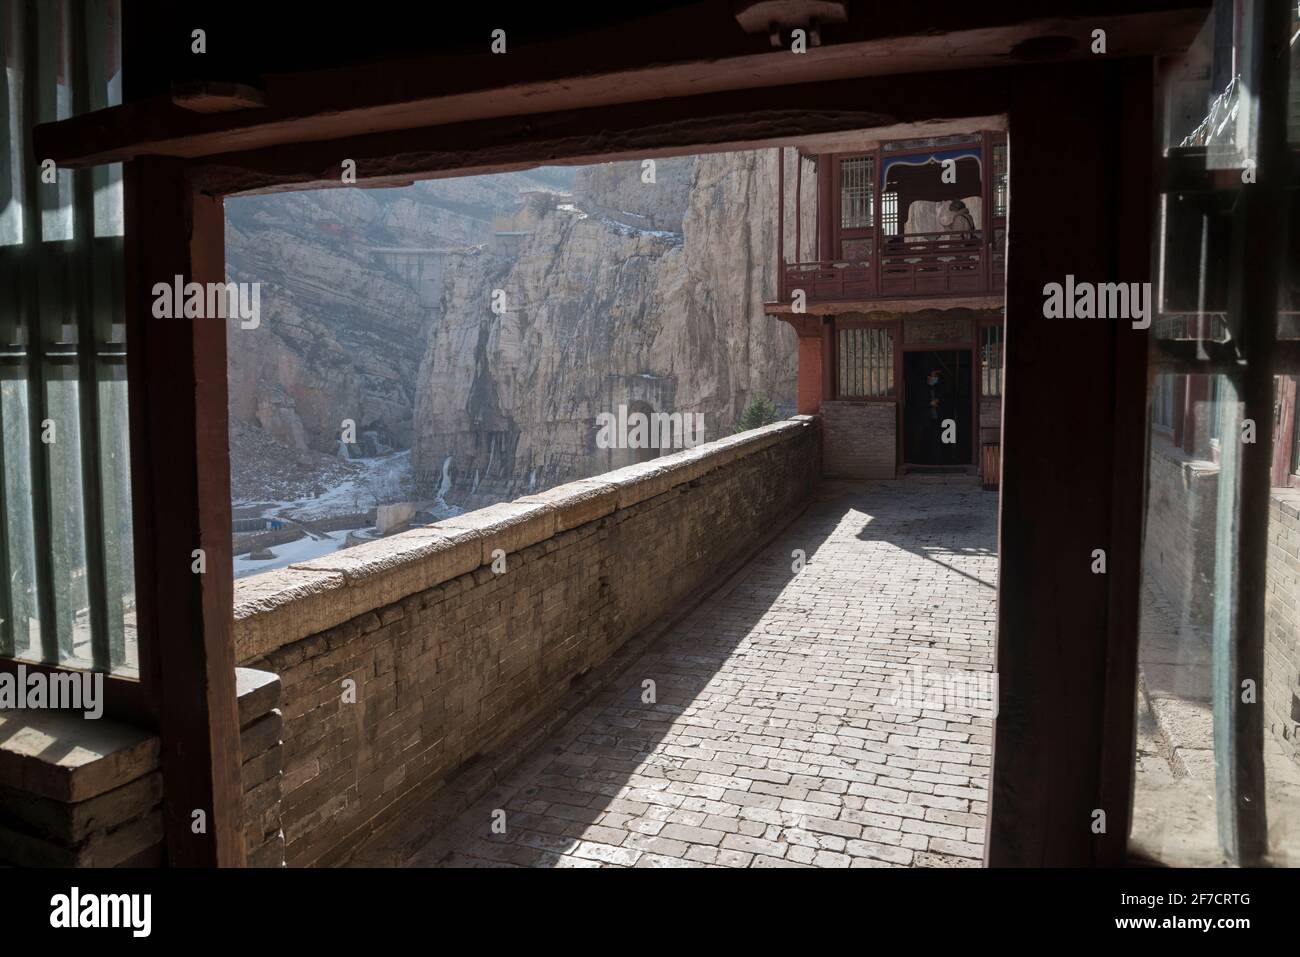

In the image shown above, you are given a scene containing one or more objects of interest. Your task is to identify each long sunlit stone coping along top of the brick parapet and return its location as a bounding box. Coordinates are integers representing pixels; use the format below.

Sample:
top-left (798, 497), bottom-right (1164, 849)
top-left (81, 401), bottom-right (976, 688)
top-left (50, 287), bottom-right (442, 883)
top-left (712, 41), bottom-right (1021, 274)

top-left (234, 415), bottom-right (816, 663)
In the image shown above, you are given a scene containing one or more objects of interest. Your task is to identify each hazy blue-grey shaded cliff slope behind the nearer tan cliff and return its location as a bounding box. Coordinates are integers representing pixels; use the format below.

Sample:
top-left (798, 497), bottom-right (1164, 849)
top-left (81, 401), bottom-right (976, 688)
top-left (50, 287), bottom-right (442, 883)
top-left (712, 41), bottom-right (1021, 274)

top-left (226, 174), bottom-right (574, 455)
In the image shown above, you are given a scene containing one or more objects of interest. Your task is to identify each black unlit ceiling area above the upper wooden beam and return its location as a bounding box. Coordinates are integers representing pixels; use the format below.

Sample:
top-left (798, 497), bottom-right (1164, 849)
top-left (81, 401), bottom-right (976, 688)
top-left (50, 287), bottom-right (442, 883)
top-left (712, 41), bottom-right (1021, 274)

top-left (126, 0), bottom-right (1206, 92)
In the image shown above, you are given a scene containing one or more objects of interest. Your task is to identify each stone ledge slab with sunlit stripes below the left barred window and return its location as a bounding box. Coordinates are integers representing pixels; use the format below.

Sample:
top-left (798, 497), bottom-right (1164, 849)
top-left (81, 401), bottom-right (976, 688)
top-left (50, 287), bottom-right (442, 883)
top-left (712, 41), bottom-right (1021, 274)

top-left (0, 709), bottom-right (160, 804)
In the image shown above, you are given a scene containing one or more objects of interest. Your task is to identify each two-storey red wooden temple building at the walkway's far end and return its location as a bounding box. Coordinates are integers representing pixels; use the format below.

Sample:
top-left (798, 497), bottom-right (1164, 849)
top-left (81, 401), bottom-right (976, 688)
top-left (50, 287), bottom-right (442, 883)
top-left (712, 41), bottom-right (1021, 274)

top-left (766, 129), bottom-right (1010, 488)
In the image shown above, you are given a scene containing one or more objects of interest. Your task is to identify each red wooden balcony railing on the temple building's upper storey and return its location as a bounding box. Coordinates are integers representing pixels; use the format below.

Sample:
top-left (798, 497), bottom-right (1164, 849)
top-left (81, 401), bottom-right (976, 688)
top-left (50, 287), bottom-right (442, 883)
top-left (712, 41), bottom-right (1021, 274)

top-left (779, 221), bottom-right (1006, 303)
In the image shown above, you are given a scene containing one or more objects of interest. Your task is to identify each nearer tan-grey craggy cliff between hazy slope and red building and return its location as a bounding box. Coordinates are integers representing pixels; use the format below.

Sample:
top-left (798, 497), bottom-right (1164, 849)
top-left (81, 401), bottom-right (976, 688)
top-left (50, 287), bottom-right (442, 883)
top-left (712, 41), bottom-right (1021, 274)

top-left (412, 151), bottom-right (796, 506)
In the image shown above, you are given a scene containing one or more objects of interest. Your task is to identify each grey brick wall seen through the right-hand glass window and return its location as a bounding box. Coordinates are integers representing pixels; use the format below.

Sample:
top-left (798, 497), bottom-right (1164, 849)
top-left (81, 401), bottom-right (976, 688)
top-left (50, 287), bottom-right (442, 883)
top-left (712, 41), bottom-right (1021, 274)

top-left (1143, 433), bottom-right (1300, 763)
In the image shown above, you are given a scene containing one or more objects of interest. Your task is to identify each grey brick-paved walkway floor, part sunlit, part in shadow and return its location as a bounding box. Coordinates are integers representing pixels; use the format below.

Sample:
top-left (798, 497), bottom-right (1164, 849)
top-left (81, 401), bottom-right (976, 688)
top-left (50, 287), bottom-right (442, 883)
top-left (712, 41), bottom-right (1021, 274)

top-left (408, 479), bottom-right (997, 867)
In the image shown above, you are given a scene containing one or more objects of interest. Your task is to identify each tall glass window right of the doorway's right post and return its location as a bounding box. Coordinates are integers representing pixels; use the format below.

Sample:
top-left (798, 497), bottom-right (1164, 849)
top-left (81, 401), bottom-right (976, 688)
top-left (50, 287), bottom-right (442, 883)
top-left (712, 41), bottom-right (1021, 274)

top-left (1131, 0), bottom-right (1300, 866)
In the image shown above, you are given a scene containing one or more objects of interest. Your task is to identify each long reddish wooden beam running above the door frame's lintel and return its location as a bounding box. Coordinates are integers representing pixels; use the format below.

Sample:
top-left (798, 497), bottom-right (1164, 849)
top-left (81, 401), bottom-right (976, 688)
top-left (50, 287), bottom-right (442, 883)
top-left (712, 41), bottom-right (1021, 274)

top-left (36, 0), bottom-right (1205, 166)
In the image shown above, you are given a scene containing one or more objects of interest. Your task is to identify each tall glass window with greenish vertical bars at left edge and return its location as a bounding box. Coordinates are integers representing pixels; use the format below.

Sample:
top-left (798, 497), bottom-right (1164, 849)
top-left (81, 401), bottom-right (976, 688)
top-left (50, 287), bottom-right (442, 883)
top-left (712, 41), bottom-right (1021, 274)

top-left (0, 0), bottom-right (129, 675)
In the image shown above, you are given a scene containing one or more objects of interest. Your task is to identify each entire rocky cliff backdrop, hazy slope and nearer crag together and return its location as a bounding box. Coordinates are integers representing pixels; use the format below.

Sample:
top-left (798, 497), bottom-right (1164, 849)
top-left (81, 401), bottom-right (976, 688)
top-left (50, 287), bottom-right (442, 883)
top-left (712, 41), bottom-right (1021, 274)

top-left (226, 151), bottom-right (813, 507)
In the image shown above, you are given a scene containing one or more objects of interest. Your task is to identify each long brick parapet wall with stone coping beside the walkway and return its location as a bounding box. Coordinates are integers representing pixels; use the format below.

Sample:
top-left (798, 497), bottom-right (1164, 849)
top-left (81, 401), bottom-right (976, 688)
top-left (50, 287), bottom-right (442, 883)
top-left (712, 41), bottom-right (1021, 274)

top-left (235, 416), bottom-right (820, 866)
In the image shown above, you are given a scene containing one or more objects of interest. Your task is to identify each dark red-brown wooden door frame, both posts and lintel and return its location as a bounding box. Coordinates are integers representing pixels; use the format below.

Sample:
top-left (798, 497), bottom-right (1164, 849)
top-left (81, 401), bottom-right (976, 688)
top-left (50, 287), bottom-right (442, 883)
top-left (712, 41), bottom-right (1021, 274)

top-left (38, 5), bottom-right (1206, 865)
